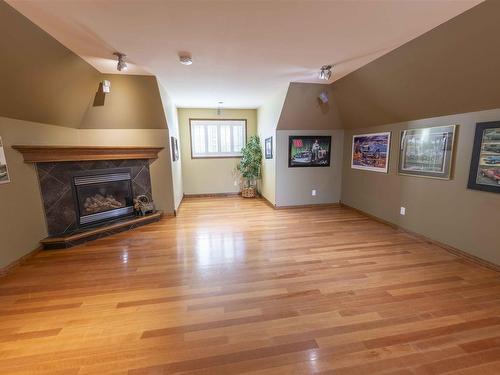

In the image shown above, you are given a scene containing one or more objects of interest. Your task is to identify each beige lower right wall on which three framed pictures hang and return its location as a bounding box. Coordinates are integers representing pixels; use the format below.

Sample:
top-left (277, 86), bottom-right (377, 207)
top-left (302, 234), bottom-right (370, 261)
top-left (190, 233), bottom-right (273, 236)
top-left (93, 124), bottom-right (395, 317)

top-left (342, 109), bottom-right (500, 264)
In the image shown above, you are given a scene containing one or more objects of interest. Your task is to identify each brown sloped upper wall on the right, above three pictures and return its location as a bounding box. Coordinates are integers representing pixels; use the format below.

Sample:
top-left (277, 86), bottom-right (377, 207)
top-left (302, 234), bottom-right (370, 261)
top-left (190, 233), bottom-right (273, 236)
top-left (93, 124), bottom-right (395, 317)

top-left (331, 0), bottom-right (500, 128)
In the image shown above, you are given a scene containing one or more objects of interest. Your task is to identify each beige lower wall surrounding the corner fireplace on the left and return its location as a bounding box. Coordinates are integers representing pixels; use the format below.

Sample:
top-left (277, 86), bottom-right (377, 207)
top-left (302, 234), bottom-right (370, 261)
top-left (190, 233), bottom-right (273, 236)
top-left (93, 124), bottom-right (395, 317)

top-left (0, 117), bottom-right (174, 268)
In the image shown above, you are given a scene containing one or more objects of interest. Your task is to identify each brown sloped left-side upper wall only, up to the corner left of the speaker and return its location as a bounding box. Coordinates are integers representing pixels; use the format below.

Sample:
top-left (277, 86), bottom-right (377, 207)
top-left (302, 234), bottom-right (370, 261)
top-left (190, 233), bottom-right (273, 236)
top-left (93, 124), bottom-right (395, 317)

top-left (0, 1), bottom-right (99, 128)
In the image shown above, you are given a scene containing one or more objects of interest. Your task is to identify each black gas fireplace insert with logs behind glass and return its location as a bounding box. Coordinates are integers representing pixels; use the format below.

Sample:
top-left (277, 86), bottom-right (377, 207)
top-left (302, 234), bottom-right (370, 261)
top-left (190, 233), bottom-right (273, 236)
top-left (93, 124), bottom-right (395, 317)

top-left (73, 169), bottom-right (134, 226)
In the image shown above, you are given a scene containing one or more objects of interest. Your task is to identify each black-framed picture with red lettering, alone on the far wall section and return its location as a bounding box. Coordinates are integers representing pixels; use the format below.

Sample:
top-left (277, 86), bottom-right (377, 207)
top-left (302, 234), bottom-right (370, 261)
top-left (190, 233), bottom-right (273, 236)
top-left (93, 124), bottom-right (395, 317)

top-left (288, 135), bottom-right (332, 168)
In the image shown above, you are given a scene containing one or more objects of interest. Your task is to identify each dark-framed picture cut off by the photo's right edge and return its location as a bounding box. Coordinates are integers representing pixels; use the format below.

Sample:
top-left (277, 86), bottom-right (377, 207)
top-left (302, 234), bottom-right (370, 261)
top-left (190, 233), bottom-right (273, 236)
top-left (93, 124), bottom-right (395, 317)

top-left (467, 121), bottom-right (500, 193)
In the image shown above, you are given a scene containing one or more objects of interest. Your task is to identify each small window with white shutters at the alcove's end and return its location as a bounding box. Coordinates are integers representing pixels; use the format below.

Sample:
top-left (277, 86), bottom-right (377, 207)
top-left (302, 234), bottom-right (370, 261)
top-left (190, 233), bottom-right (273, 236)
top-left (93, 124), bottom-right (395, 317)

top-left (189, 120), bottom-right (247, 158)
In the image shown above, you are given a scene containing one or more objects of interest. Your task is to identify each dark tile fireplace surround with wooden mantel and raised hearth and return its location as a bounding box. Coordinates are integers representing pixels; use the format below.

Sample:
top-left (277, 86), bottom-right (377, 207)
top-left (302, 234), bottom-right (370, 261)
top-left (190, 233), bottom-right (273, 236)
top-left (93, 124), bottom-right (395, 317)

top-left (12, 145), bottom-right (163, 249)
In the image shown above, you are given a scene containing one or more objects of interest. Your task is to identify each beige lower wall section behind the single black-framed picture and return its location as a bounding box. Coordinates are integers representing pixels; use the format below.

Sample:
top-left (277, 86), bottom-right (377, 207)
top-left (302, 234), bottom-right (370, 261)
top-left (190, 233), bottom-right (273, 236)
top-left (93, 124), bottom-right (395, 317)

top-left (276, 130), bottom-right (344, 207)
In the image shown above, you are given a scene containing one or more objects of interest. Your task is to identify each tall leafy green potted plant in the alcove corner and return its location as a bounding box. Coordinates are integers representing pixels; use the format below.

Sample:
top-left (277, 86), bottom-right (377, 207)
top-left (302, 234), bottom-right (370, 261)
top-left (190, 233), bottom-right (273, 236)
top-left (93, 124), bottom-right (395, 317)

top-left (236, 135), bottom-right (262, 198)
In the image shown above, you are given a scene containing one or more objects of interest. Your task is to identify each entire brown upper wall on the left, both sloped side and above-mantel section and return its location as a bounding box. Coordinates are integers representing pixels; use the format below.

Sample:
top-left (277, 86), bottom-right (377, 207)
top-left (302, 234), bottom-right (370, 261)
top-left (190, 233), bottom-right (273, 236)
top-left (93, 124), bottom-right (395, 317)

top-left (0, 0), bottom-right (167, 129)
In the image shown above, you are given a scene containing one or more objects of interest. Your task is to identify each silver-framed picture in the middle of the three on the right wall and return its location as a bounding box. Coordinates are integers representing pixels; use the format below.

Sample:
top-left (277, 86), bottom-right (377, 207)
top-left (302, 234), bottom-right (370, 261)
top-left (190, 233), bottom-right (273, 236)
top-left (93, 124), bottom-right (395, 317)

top-left (398, 125), bottom-right (457, 180)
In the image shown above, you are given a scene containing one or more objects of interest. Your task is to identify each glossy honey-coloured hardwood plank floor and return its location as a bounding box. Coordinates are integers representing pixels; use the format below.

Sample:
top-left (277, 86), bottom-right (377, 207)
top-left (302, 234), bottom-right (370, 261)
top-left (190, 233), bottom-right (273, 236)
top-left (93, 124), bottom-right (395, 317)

top-left (0, 198), bottom-right (500, 375)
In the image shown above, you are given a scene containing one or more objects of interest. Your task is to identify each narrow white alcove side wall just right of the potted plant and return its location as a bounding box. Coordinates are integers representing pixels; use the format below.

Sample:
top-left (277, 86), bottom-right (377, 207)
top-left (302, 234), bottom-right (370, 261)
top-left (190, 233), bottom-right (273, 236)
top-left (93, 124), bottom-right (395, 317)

top-left (257, 85), bottom-right (288, 204)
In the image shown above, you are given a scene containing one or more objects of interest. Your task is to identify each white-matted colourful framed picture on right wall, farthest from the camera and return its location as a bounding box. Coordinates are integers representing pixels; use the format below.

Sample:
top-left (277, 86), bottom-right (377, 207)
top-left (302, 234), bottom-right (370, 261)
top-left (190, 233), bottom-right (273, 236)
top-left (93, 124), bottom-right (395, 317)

top-left (351, 132), bottom-right (391, 173)
